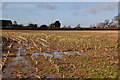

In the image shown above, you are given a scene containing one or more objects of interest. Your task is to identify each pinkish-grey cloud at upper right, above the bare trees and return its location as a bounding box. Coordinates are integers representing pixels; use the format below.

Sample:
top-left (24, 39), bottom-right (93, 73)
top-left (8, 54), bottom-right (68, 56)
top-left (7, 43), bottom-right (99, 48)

top-left (87, 4), bottom-right (115, 13)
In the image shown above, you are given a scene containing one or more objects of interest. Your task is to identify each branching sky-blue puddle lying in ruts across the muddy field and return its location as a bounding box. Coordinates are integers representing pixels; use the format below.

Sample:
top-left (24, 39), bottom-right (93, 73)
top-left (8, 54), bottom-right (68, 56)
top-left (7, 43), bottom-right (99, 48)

top-left (4, 38), bottom-right (90, 70)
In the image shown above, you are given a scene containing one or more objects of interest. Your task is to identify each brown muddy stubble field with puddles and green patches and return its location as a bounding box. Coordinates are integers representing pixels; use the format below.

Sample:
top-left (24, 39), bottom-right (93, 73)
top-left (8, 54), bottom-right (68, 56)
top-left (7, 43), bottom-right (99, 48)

top-left (0, 30), bottom-right (120, 78)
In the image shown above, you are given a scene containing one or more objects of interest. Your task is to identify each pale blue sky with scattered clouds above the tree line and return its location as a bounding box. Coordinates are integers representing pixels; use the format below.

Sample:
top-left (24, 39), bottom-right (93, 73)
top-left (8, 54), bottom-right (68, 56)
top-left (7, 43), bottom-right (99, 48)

top-left (0, 2), bottom-right (118, 27)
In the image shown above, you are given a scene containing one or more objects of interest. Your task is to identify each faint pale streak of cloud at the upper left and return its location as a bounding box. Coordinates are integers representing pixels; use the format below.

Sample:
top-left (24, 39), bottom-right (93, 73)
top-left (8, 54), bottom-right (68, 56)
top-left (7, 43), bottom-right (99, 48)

top-left (2, 3), bottom-right (36, 9)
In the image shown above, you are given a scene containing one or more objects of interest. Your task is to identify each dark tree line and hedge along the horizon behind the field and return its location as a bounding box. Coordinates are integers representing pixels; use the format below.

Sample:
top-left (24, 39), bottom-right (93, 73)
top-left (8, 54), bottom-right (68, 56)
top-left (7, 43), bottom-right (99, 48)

top-left (2, 14), bottom-right (120, 30)
